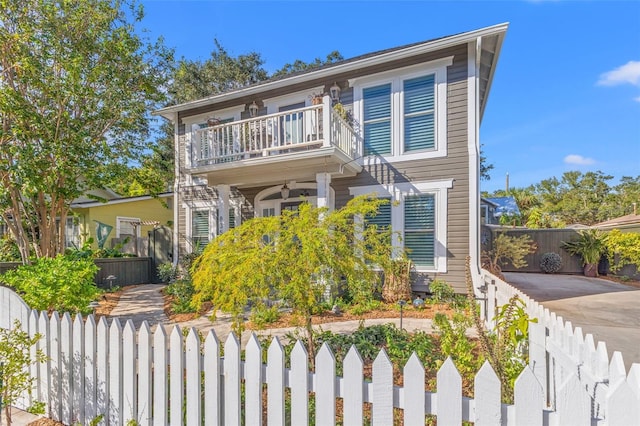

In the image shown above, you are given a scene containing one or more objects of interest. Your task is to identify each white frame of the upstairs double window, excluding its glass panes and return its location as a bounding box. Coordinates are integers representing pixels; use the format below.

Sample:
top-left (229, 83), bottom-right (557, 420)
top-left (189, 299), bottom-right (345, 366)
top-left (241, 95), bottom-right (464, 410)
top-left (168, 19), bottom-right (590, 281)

top-left (349, 56), bottom-right (453, 165)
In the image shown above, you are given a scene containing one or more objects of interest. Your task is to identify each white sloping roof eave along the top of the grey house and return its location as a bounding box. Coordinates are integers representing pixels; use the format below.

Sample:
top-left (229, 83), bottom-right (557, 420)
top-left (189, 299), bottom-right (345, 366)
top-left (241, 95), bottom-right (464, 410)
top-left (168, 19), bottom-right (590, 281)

top-left (152, 22), bottom-right (509, 120)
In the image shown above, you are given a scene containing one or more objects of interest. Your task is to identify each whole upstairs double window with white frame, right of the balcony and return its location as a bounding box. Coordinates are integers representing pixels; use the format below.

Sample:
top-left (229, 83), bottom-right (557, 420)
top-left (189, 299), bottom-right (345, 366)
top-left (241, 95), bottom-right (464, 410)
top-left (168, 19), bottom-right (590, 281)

top-left (350, 56), bottom-right (453, 162)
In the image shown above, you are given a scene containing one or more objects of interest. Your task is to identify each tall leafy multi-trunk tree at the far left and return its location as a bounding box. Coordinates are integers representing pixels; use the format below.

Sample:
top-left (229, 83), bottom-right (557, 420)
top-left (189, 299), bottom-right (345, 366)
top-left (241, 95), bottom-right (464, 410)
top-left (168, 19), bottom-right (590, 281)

top-left (0, 0), bottom-right (171, 263)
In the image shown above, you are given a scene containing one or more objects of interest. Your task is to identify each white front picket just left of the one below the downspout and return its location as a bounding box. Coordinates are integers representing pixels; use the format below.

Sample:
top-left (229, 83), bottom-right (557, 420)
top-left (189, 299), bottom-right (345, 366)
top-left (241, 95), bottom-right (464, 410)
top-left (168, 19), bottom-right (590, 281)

top-left (436, 357), bottom-right (462, 425)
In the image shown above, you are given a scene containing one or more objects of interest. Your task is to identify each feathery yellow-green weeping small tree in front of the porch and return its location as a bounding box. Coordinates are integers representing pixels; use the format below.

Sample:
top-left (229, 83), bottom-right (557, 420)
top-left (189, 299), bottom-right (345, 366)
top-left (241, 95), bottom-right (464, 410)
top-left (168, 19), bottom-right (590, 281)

top-left (192, 196), bottom-right (392, 359)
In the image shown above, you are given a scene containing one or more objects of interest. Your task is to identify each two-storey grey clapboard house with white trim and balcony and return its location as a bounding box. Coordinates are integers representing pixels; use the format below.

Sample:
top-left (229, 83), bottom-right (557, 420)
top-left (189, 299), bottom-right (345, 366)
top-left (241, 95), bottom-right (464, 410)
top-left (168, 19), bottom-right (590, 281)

top-left (155, 24), bottom-right (508, 291)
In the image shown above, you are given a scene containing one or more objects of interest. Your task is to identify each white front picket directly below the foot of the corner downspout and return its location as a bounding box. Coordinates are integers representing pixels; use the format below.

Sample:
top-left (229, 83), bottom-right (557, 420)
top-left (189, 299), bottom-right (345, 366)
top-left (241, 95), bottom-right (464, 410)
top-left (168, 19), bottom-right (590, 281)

top-left (473, 361), bottom-right (502, 426)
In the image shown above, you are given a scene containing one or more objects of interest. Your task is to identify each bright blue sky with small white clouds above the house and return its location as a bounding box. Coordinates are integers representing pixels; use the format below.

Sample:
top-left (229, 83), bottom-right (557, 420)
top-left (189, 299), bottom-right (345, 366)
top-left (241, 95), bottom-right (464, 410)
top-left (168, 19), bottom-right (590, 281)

top-left (143, 0), bottom-right (640, 191)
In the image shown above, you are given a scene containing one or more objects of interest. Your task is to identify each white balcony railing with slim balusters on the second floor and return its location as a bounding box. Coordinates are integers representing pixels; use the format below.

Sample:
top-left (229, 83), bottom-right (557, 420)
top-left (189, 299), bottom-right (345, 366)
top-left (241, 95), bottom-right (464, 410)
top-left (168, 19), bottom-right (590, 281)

top-left (191, 97), bottom-right (359, 167)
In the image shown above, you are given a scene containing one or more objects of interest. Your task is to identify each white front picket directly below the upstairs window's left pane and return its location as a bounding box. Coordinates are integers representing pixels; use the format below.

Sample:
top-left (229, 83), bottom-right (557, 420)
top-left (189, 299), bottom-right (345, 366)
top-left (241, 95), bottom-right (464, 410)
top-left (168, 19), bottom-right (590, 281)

top-left (371, 349), bottom-right (393, 425)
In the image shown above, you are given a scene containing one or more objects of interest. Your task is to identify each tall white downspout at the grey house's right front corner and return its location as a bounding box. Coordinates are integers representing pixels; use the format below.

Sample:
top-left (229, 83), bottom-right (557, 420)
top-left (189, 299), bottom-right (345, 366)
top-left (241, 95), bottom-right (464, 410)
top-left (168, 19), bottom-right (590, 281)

top-left (467, 37), bottom-right (482, 292)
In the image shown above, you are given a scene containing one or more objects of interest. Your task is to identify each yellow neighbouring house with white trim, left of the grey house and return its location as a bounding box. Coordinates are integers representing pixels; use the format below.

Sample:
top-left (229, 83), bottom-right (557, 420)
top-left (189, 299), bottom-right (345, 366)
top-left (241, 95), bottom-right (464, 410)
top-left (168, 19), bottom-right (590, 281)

top-left (67, 193), bottom-right (173, 255)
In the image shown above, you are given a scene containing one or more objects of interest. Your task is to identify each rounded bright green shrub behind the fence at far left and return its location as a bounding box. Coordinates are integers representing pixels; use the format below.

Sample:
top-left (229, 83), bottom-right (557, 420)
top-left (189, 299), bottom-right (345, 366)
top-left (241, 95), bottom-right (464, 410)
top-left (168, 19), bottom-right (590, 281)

top-left (0, 256), bottom-right (100, 314)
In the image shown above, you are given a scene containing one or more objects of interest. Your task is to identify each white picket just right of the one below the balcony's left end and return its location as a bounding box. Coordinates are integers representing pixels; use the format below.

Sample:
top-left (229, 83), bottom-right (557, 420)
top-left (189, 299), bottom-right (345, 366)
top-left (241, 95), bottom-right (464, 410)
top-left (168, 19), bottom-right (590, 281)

top-left (203, 330), bottom-right (223, 426)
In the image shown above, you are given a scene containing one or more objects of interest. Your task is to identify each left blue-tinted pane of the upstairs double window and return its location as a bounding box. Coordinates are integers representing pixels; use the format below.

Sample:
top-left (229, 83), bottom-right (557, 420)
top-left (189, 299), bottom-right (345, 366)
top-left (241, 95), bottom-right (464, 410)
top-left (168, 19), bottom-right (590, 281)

top-left (362, 84), bottom-right (391, 155)
